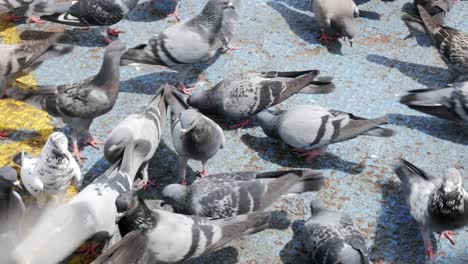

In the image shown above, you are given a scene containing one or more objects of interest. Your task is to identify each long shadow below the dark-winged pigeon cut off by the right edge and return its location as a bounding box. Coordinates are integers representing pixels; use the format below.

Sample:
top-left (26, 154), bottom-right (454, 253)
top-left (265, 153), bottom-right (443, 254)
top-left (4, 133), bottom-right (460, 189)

top-left (388, 114), bottom-right (468, 145)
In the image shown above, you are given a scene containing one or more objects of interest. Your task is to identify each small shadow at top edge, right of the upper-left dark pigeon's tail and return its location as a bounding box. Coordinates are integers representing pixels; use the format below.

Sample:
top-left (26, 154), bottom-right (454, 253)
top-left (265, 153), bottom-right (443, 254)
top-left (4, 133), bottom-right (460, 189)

top-left (126, 0), bottom-right (172, 22)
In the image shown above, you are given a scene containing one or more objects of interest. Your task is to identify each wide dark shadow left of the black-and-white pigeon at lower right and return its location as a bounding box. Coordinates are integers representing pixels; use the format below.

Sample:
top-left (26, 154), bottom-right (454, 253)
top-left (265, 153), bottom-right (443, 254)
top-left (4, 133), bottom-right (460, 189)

top-left (369, 182), bottom-right (436, 263)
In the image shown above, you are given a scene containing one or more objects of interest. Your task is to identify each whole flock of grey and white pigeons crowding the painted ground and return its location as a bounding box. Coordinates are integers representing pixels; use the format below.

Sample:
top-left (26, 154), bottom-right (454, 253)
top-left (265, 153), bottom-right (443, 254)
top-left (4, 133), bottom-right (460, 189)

top-left (0, 0), bottom-right (468, 263)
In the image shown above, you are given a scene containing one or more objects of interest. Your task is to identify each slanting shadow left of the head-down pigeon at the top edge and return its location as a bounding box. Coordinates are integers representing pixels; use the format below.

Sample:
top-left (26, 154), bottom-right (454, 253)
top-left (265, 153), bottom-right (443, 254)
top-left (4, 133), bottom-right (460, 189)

top-left (267, 1), bottom-right (343, 55)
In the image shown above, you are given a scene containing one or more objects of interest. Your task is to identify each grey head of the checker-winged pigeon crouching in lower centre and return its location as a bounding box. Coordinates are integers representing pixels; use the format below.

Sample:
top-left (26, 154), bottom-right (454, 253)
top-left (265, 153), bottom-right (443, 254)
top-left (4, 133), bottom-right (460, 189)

top-left (162, 184), bottom-right (190, 213)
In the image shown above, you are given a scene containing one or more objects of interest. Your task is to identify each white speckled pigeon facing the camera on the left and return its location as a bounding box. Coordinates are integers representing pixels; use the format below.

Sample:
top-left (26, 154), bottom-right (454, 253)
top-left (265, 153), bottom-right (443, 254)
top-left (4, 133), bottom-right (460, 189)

top-left (17, 132), bottom-right (83, 208)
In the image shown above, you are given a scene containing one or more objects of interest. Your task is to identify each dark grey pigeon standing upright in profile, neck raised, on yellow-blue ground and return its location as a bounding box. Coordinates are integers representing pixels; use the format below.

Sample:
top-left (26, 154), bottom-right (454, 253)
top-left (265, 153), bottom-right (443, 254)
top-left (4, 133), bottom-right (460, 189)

top-left (7, 41), bottom-right (126, 163)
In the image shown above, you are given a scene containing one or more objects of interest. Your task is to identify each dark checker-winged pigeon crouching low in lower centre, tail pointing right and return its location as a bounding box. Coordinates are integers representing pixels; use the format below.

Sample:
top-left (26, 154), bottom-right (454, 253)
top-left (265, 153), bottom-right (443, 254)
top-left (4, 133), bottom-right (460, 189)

top-left (162, 170), bottom-right (325, 218)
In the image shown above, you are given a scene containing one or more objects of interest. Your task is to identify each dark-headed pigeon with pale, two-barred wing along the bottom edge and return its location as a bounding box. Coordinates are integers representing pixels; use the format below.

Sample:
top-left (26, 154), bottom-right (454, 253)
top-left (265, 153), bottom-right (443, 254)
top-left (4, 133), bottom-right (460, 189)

top-left (93, 192), bottom-right (289, 264)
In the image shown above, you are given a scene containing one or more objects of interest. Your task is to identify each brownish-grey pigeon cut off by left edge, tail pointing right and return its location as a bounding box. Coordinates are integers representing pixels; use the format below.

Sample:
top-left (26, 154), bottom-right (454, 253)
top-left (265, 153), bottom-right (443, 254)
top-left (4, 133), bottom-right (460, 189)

top-left (0, 33), bottom-right (73, 99)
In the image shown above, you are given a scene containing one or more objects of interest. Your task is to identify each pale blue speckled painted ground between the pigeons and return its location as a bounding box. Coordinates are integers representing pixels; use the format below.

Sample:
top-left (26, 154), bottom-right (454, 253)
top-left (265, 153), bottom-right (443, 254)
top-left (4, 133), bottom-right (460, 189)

top-left (0, 0), bottom-right (468, 263)
